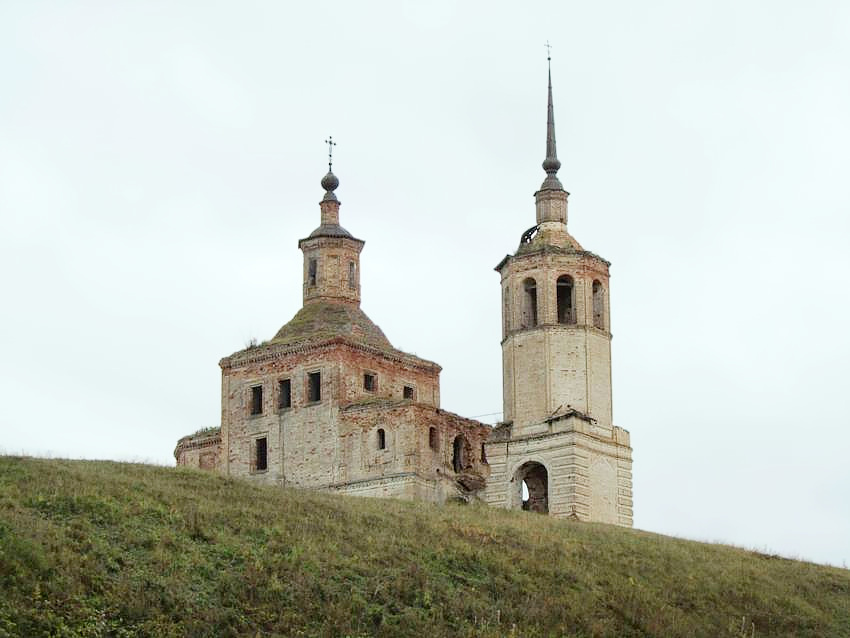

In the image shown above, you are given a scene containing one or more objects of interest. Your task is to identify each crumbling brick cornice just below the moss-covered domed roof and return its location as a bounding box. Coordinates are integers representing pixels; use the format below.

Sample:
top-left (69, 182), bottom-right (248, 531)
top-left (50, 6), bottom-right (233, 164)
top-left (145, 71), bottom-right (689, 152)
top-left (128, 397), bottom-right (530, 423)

top-left (218, 335), bottom-right (443, 374)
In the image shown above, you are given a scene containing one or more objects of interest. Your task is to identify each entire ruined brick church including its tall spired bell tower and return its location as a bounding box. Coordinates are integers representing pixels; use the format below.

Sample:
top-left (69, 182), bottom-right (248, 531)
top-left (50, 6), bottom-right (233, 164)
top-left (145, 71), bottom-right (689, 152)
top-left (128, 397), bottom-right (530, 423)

top-left (174, 62), bottom-right (632, 526)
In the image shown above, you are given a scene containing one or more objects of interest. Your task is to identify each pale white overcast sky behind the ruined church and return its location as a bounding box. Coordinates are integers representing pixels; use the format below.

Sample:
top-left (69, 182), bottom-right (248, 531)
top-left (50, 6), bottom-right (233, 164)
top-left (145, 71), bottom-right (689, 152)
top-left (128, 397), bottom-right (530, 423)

top-left (0, 0), bottom-right (850, 565)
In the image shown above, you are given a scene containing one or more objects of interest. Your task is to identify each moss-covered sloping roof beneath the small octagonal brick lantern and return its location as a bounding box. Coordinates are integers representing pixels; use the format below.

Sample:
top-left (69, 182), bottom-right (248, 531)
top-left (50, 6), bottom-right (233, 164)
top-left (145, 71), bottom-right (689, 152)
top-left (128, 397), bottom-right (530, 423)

top-left (269, 301), bottom-right (392, 350)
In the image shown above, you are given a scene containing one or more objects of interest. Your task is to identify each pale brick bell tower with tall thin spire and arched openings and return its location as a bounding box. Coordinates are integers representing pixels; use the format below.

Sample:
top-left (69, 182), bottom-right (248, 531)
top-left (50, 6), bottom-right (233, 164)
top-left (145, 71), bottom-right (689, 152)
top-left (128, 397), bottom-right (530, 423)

top-left (480, 53), bottom-right (632, 526)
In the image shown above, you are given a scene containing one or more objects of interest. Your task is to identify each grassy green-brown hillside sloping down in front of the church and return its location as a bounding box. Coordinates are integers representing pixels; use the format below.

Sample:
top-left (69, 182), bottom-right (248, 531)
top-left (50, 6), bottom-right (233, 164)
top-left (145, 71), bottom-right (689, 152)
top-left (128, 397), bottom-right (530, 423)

top-left (0, 457), bottom-right (850, 637)
